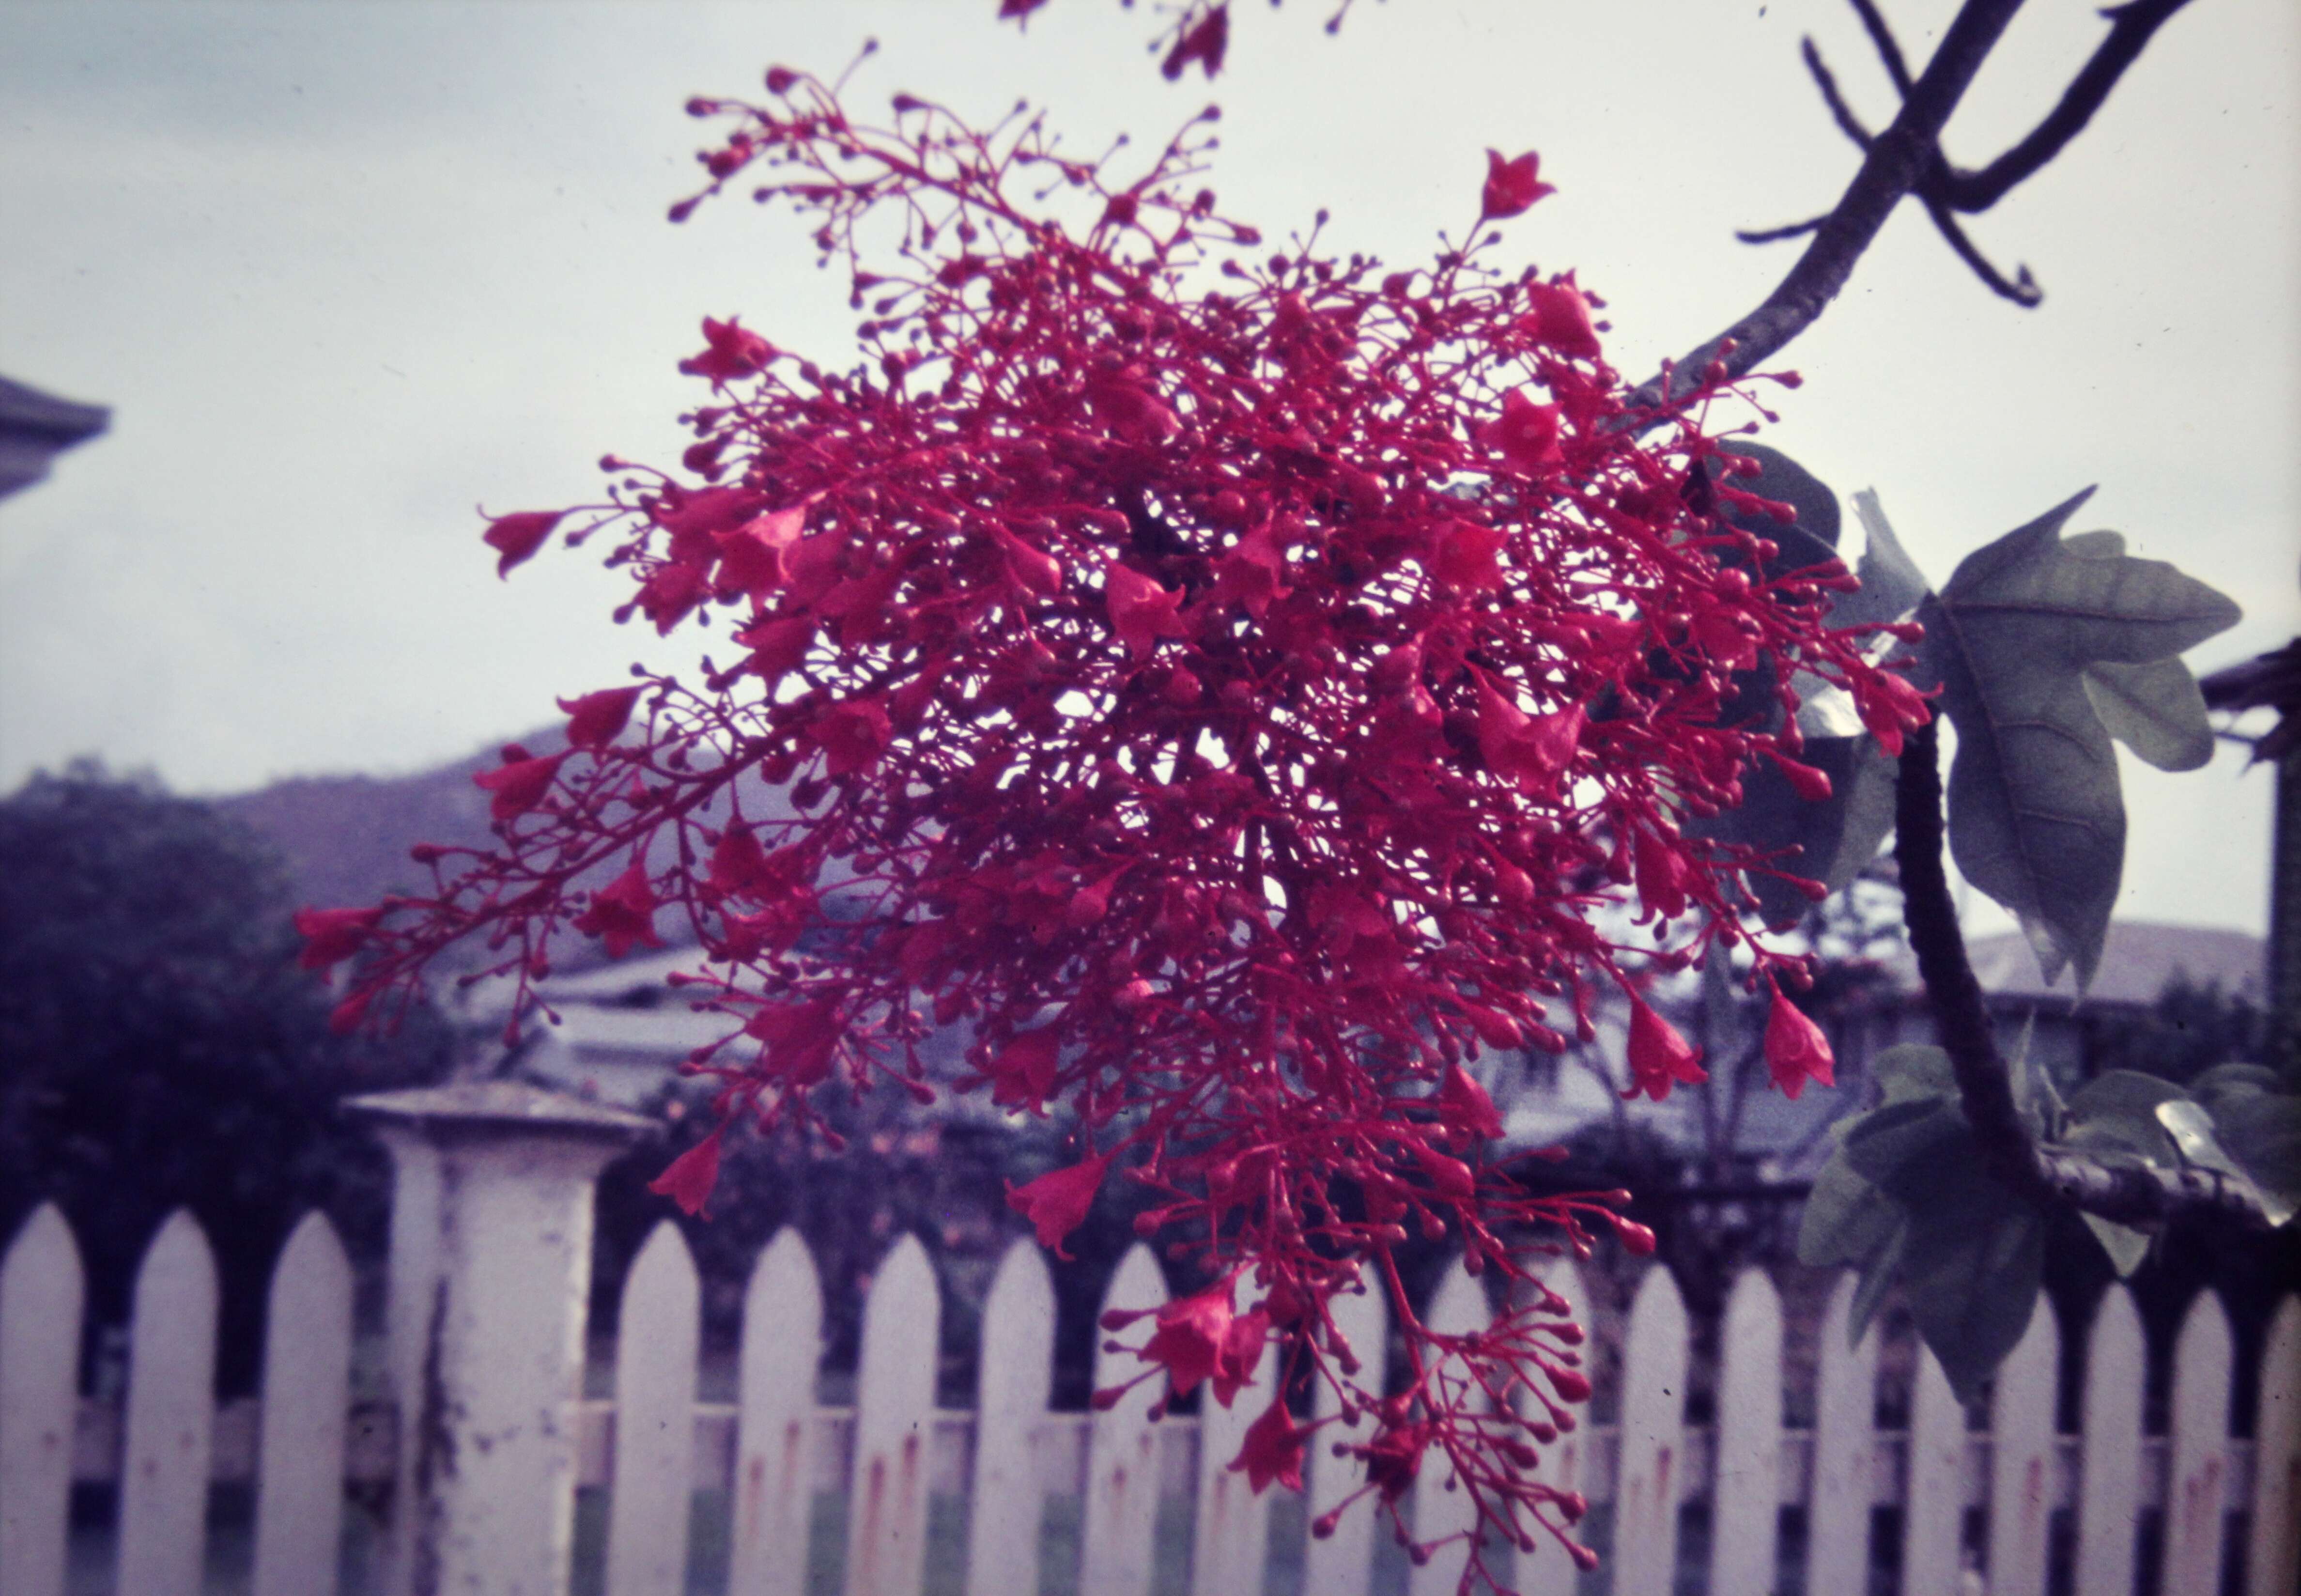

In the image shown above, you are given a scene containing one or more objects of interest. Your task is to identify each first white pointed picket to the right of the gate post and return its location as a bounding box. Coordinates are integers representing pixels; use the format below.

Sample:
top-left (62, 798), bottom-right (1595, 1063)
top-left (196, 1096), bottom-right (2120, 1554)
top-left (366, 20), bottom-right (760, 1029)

top-left (607, 1219), bottom-right (702, 1596)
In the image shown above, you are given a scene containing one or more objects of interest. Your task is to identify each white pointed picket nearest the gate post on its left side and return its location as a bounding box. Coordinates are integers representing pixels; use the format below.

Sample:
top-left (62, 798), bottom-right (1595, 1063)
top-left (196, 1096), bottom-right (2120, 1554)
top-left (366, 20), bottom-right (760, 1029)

top-left (253, 1212), bottom-right (352, 1596)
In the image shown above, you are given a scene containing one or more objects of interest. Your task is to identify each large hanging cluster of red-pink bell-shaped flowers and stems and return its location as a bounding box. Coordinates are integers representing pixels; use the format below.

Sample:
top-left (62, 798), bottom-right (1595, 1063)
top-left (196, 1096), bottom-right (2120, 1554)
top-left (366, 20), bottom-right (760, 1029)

top-left (306, 69), bottom-right (1926, 1578)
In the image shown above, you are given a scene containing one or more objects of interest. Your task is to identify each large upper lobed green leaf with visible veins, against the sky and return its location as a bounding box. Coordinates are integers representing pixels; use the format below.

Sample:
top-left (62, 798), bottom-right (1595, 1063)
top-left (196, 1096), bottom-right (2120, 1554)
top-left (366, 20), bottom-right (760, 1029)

top-left (1921, 490), bottom-right (2239, 989)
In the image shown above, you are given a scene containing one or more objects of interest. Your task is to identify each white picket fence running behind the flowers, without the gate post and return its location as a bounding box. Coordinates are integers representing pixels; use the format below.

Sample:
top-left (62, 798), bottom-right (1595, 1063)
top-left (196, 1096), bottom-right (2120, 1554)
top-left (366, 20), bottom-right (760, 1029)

top-left (0, 1163), bottom-right (2301, 1596)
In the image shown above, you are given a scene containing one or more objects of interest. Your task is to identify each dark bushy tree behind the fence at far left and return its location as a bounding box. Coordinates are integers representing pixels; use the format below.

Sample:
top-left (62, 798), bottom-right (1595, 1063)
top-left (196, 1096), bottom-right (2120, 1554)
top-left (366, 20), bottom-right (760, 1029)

top-left (0, 763), bottom-right (448, 1391)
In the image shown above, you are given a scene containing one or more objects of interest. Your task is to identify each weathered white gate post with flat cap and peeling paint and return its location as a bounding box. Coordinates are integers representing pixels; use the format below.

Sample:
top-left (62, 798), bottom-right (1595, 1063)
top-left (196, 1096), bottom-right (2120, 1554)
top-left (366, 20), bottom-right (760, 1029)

top-left (345, 1081), bottom-right (653, 1596)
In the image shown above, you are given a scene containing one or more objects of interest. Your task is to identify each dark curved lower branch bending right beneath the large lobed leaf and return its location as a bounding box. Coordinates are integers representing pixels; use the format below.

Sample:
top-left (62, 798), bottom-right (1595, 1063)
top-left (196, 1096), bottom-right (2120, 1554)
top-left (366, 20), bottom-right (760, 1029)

top-left (1894, 722), bottom-right (2269, 1228)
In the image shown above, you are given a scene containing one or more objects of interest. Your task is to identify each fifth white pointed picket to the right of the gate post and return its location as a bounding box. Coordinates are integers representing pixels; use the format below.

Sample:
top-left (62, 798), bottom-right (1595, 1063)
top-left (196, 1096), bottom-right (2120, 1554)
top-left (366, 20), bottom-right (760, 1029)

top-left (1079, 1242), bottom-right (1167, 1596)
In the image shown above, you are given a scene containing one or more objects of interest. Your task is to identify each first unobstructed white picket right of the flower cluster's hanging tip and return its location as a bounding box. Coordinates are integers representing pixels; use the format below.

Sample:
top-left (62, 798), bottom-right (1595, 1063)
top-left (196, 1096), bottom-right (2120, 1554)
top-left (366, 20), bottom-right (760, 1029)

top-left (1611, 1267), bottom-right (1691, 1592)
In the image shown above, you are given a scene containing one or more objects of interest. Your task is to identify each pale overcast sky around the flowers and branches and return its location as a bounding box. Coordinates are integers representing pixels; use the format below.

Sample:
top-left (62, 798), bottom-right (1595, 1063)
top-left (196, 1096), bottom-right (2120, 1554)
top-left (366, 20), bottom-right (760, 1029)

top-left (0, 0), bottom-right (2301, 929)
